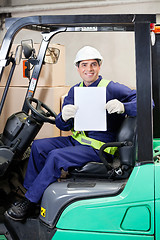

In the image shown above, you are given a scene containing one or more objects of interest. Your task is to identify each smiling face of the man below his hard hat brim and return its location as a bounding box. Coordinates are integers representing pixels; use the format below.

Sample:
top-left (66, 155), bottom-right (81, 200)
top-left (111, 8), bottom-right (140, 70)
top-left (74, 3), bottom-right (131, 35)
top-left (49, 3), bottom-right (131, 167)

top-left (77, 59), bottom-right (100, 87)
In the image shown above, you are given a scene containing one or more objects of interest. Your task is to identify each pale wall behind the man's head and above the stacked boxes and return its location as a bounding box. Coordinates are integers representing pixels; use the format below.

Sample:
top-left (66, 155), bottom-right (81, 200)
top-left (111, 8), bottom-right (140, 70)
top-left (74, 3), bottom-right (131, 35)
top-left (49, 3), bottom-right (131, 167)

top-left (0, 1), bottom-right (160, 88)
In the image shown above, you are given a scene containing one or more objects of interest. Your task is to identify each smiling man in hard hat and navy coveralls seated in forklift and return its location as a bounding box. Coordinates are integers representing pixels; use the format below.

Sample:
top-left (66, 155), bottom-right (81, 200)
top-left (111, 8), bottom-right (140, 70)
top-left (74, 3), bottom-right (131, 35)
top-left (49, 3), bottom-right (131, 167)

top-left (5, 46), bottom-right (137, 221)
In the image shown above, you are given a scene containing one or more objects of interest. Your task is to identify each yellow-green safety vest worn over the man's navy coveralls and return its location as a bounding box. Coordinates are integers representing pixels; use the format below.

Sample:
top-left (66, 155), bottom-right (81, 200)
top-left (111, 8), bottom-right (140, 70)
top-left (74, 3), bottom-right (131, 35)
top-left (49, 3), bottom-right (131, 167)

top-left (71, 79), bottom-right (117, 155)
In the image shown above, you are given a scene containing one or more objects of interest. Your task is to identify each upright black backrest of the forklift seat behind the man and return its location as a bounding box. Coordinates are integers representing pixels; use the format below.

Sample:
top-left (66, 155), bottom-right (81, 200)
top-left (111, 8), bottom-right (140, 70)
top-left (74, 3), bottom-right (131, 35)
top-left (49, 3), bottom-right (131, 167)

top-left (117, 117), bottom-right (137, 166)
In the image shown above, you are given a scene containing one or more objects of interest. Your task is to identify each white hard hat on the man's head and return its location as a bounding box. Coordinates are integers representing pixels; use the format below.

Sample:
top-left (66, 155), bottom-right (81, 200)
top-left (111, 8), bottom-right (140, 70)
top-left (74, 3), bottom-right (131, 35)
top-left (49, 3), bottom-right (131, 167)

top-left (74, 46), bottom-right (103, 65)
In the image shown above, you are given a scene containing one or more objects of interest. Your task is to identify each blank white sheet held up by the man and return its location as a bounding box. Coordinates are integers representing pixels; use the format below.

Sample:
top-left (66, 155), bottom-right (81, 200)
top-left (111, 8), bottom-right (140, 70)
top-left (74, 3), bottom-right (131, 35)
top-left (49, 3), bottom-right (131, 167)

top-left (74, 87), bottom-right (107, 131)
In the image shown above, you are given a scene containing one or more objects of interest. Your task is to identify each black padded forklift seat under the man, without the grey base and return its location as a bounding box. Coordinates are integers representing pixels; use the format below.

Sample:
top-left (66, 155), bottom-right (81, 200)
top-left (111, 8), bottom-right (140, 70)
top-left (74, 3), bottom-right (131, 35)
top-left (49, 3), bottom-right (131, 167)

top-left (69, 117), bottom-right (137, 179)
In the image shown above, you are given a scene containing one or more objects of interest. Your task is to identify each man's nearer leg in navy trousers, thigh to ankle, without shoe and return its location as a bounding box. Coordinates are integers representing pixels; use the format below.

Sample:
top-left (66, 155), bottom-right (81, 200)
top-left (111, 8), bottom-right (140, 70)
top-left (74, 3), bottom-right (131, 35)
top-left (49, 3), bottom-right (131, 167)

top-left (25, 145), bottom-right (100, 203)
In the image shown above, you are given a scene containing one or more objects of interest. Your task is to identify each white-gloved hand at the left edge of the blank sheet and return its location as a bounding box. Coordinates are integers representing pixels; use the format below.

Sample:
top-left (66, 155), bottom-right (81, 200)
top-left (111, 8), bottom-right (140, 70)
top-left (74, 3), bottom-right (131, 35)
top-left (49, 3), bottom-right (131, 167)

top-left (62, 104), bottom-right (78, 122)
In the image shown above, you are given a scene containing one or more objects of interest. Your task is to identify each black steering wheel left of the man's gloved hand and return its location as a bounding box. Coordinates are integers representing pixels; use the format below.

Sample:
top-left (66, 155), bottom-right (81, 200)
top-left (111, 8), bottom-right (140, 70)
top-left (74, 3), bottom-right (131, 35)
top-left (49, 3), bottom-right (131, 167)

top-left (26, 97), bottom-right (57, 124)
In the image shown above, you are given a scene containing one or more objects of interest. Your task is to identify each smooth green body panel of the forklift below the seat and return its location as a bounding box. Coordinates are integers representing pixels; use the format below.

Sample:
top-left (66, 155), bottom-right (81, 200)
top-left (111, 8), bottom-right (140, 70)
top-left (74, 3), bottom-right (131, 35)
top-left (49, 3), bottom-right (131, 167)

top-left (53, 164), bottom-right (157, 240)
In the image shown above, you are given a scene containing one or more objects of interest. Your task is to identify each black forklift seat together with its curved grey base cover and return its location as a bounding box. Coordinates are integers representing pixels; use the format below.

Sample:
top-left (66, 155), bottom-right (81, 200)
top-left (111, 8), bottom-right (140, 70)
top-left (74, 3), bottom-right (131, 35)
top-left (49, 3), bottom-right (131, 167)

top-left (39, 117), bottom-right (136, 228)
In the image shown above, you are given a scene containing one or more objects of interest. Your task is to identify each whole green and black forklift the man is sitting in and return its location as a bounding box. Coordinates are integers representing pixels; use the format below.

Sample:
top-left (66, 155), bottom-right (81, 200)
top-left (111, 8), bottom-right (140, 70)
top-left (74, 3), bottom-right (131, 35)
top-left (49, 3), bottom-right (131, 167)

top-left (0, 14), bottom-right (160, 240)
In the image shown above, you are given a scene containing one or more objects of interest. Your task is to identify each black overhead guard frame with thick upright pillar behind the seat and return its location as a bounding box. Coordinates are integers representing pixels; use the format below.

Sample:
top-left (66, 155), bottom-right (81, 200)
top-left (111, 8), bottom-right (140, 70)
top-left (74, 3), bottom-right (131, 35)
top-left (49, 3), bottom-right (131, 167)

top-left (0, 14), bottom-right (156, 164)
